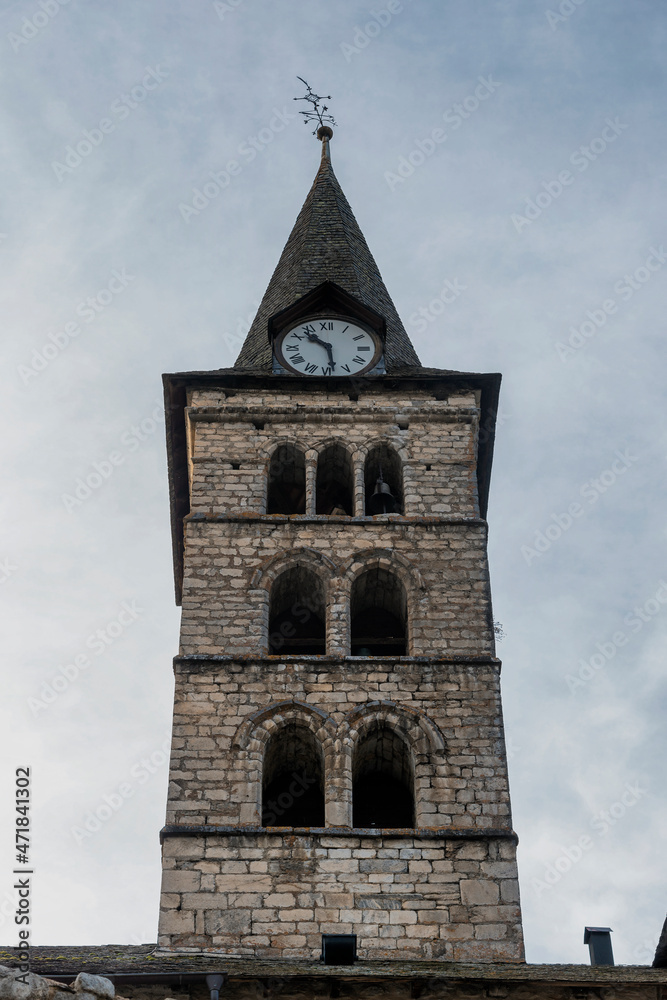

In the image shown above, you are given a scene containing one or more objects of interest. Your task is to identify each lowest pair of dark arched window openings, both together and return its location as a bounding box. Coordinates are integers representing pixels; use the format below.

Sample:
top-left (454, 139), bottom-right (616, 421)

top-left (261, 722), bottom-right (415, 829)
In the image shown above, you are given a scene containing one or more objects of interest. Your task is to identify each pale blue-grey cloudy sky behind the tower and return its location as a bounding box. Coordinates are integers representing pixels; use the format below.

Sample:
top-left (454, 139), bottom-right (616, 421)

top-left (0, 0), bottom-right (667, 964)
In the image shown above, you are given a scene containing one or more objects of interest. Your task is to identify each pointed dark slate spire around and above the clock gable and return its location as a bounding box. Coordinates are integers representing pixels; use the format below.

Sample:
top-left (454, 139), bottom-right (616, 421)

top-left (234, 127), bottom-right (420, 372)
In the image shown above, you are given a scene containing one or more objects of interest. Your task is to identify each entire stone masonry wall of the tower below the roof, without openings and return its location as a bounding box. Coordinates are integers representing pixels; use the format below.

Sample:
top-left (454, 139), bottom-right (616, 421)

top-left (160, 383), bottom-right (523, 962)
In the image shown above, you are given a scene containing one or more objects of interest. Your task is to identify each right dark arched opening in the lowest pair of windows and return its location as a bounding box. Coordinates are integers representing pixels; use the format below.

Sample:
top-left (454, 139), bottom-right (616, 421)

top-left (352, 723), bottom-right (415, 829)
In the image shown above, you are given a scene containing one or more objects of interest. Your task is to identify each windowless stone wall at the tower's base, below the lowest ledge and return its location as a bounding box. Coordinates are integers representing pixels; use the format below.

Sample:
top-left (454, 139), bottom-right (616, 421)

top-left (158, 833), bottom-right (523, 962)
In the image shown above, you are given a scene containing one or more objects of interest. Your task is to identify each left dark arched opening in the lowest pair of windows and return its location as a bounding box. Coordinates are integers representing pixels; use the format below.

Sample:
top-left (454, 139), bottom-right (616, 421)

top-left (262, 722), bottom-right (324, 826)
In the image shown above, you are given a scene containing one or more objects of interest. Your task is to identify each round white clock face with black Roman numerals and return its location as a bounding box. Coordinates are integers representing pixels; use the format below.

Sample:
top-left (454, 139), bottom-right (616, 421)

top-left (276, 317), bottom-right (382, 376)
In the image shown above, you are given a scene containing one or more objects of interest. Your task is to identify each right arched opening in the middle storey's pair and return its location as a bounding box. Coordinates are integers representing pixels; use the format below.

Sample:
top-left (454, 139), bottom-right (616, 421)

top-left (350, 568), bottom-right (408, 656)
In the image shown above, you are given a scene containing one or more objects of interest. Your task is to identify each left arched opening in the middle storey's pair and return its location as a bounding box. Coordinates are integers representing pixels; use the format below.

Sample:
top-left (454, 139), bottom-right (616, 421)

top-left (269, 566), bottom-right (326, 656)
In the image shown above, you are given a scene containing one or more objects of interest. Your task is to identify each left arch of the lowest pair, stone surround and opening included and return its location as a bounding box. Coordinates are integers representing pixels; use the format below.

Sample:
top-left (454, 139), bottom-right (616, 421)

top-left (233, 700), bottom-right (336, 826)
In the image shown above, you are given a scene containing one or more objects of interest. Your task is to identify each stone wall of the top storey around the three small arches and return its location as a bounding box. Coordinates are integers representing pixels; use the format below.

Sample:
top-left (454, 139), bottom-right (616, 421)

top-left (188, 390), bottom-right (479, 517)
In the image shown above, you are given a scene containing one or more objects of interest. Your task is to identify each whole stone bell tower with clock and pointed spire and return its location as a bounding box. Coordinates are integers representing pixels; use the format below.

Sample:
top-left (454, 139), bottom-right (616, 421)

top-left (159, 127), bottom-right (523, 962)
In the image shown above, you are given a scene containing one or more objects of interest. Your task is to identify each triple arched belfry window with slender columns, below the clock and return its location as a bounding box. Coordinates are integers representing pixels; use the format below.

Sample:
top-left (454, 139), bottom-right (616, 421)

top-left (266, 442), bottom-right (403, 516)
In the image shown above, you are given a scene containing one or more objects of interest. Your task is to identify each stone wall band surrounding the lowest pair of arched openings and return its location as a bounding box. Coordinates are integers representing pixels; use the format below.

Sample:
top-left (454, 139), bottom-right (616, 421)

top-left (167, 657), bottom-right (512, 831)
